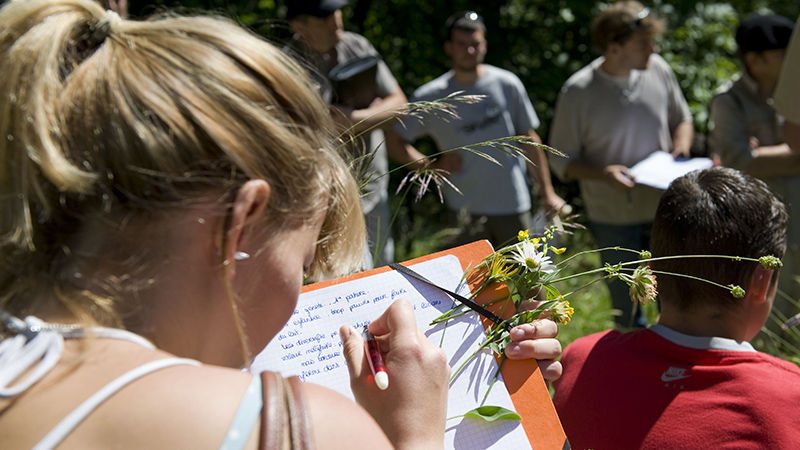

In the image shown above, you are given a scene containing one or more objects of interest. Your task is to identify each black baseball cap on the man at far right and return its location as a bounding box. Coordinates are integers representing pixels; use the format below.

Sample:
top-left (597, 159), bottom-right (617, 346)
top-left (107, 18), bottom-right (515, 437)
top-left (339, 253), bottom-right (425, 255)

top-left (736, 14), bottom-right (794, 53)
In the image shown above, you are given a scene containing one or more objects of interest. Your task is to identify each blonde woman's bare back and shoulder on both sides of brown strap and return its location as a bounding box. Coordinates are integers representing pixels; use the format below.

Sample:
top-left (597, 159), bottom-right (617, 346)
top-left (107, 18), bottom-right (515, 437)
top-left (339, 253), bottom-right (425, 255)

top-left (0, 344), bottom-right (392, 450)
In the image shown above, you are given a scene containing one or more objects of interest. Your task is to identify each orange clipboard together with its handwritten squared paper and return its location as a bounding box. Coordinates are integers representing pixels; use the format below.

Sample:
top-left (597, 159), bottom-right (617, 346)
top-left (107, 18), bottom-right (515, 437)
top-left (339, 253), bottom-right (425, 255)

top-left (252, 241), bottom-right (568, 450)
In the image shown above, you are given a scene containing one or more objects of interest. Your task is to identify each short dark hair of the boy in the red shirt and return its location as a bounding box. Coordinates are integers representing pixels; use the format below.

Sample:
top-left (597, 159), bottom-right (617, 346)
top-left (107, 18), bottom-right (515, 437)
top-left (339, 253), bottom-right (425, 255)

top-left (651, 167), bottom-right (789, 310)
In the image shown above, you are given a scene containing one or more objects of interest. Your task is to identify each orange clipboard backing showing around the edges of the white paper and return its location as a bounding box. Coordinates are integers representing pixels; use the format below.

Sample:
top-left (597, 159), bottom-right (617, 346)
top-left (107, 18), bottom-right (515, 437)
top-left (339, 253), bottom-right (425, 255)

top-left (302, 241), bottom-right (569, 450)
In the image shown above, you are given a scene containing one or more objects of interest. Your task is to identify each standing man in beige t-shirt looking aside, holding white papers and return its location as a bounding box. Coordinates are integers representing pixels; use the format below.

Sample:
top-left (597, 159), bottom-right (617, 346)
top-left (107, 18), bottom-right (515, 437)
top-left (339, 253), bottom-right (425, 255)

top-left (550, 2), bottom-right (694, 328)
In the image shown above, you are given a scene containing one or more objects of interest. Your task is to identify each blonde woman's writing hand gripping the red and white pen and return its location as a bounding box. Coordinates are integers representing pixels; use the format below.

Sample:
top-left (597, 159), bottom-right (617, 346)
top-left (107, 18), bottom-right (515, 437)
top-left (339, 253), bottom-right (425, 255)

top-left (339, 300), bottom-right (450, 449)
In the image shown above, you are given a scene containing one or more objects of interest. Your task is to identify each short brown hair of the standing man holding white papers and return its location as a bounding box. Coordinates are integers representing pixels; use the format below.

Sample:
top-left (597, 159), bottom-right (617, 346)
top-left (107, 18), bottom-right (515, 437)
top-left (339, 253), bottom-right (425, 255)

top-left (592, 1), bottom-right (666, 54)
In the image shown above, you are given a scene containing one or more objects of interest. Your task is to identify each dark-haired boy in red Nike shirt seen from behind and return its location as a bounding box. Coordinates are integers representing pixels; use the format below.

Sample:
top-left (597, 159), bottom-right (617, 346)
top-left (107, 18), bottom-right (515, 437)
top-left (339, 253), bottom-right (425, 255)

top-left (553, 167), bottom-right (800, 450)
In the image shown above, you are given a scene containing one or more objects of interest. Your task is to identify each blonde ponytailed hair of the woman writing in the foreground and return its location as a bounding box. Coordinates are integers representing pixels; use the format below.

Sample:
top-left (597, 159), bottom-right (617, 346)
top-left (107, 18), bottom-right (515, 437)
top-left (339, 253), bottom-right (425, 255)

top-left (0, 0), bottom-right (365, 323)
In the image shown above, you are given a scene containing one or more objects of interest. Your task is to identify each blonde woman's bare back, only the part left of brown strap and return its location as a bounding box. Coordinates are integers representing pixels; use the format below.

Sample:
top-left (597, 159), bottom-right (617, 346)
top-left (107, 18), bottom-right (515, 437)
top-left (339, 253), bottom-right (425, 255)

top-left (0, 343), bottom-right (257, 450)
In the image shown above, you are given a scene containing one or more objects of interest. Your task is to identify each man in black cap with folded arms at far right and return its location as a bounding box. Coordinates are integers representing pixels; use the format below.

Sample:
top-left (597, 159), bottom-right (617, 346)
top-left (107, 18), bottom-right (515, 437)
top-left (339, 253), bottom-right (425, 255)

top-left (708, 14), bottom-right (800, 322)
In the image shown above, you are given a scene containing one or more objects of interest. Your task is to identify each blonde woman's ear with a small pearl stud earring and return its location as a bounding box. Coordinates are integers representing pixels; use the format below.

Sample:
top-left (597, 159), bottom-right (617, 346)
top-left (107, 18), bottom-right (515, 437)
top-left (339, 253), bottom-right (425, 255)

top-left (223, 180), bottom-right (271, 271)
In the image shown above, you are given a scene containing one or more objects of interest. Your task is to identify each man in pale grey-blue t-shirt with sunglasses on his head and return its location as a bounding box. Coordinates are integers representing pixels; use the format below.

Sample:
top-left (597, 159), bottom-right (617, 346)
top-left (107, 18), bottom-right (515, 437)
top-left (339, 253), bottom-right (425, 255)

top-left (386, 11), bottom-right (564, 246)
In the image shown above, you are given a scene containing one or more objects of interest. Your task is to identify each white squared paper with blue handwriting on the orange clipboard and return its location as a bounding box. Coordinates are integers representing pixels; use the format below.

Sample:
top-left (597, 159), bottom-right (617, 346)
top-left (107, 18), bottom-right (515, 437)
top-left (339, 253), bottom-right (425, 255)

top-left (252, 255), bottom-right (531, 450)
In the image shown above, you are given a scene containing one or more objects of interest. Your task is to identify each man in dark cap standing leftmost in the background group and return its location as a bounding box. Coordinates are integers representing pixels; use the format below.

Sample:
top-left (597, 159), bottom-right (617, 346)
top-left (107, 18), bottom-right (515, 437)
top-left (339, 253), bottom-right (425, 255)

top-left (286, 0), bottom-right (407, 268)
